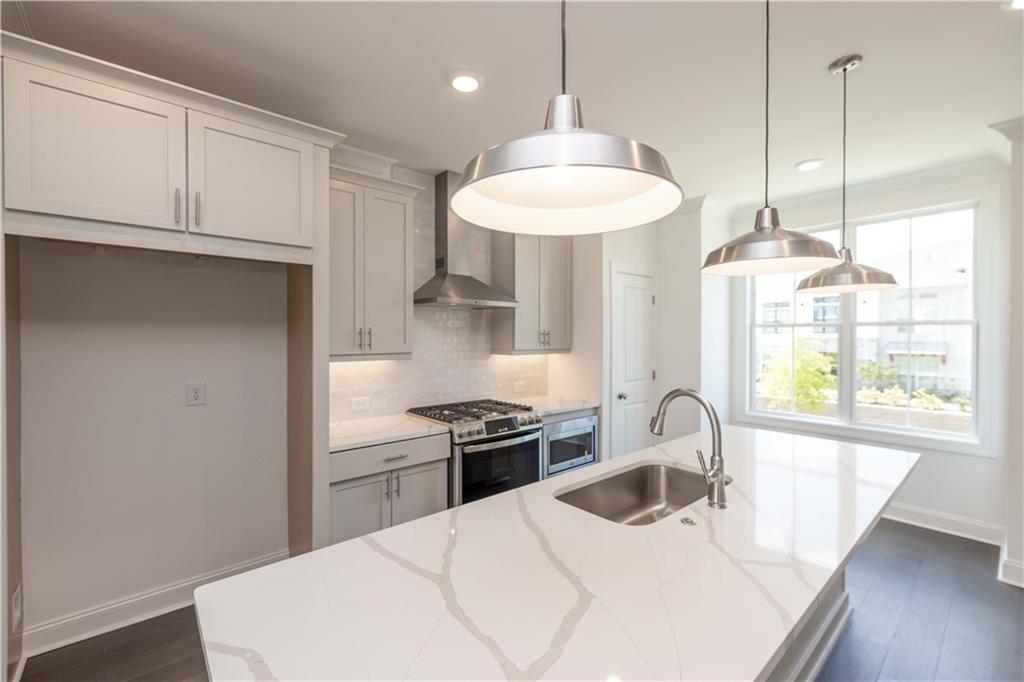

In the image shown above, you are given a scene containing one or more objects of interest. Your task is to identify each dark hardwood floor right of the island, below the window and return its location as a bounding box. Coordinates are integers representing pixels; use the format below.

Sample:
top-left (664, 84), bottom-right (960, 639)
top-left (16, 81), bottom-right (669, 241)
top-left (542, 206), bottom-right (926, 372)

top-left (818, 519), bottom-right (1024, 682)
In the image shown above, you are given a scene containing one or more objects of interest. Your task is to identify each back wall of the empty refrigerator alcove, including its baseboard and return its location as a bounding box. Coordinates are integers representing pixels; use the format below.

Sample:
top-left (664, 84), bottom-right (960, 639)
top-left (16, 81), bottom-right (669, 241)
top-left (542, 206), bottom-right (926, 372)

top-left (22, 239), bottom-right (288, 651)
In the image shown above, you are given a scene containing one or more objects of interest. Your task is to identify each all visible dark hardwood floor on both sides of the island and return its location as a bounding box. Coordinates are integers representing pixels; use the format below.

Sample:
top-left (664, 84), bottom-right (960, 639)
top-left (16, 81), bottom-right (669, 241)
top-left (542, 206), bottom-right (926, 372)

top-left (22, 519), bottom-right (1024, 682)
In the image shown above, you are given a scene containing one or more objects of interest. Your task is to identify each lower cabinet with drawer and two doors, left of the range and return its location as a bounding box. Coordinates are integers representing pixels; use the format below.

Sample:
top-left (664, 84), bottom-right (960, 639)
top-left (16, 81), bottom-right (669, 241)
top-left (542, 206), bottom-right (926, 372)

top-left (331, 434), bottom-right (451, 543)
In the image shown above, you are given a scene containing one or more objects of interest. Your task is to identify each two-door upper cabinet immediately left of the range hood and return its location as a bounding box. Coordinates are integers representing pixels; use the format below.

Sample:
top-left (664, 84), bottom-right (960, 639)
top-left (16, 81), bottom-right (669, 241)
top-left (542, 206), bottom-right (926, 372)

top-left (331, 174), bottom-right (417, 355)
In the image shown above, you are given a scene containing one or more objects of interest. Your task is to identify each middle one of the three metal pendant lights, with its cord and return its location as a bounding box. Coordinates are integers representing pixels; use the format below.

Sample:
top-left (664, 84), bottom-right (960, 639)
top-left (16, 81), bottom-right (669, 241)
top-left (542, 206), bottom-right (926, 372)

top-left (701, 2), bottom-right (839, 276)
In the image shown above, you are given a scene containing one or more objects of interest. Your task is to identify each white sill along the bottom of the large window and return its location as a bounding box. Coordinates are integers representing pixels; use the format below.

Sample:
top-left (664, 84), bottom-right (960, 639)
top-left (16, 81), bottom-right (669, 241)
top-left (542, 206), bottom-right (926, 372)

top-left (736, 412), bottom-right (995, 459)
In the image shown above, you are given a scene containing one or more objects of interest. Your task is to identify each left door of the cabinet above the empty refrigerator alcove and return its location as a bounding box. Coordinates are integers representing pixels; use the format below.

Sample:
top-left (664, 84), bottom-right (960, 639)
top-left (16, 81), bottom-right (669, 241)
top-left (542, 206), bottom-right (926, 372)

top-left (3, 58), bottom-right (185, 229)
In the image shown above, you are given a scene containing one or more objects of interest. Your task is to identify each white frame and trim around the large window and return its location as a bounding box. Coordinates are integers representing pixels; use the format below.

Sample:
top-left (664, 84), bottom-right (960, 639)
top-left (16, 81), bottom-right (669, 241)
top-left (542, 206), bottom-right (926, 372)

top-left (731, 164), bottom-right (1010, 458)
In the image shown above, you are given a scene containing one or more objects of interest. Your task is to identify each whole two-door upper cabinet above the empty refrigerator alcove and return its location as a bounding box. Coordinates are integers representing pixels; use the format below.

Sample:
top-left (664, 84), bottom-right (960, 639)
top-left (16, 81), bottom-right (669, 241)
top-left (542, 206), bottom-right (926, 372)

top-left (2, 34), bottom-right (344, 264)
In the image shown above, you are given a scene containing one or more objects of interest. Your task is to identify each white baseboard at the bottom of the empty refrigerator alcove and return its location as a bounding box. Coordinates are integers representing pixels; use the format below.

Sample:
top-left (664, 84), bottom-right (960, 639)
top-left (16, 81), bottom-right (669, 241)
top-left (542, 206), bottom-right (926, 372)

top-left (25, 550), bottom-right (288, 657)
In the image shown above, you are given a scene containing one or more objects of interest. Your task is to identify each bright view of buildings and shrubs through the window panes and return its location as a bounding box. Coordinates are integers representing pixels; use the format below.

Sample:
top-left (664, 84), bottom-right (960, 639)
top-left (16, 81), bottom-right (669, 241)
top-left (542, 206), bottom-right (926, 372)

top-left (750, 208), bottom-right (977, 436)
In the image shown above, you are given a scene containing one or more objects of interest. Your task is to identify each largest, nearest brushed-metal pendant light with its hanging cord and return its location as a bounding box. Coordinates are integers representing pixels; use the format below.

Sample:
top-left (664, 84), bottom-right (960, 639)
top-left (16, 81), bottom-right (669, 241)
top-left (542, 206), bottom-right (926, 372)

top-left (452, 0), bottom-right (683, 235)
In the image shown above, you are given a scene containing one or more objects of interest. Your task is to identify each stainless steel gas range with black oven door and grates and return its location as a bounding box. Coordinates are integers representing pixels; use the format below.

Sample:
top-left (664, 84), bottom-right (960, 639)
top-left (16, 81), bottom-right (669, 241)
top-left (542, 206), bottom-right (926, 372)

top-left (409, 400), bottom-right (544, 507)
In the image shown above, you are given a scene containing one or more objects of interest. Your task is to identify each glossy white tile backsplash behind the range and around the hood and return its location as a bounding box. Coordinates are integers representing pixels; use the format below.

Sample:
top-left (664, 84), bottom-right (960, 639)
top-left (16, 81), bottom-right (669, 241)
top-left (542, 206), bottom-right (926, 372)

top-left (331, 167), bottom-right (548, 422)
